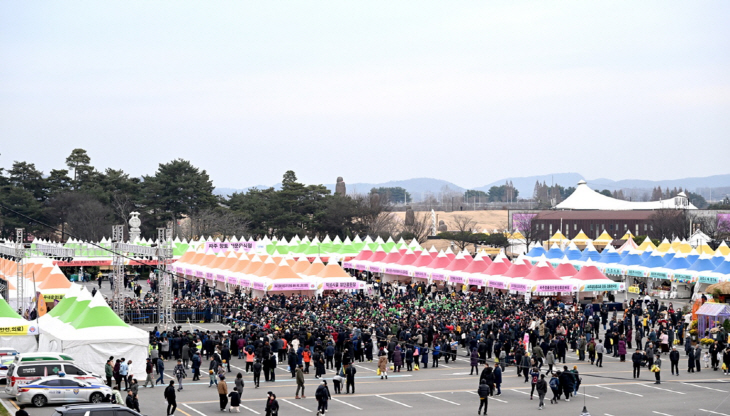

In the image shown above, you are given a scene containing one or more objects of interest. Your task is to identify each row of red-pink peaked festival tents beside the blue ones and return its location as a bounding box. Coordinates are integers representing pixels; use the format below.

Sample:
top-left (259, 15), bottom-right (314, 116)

top-left (343, 242), bottom-right (624, 294)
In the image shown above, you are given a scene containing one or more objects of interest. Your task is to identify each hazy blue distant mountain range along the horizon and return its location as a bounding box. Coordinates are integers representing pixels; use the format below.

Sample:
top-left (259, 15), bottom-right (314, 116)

top-left (215, 172), bottom-right (730, 201)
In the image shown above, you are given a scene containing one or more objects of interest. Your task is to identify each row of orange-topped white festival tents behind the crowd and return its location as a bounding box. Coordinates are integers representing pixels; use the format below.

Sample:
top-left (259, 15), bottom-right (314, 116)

top-left (172, 247), bottom-right (365, 296)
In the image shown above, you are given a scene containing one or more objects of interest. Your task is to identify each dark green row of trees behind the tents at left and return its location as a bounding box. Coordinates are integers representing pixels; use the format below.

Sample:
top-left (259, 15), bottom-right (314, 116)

top-left (0, 149), bottom-right (430, 242)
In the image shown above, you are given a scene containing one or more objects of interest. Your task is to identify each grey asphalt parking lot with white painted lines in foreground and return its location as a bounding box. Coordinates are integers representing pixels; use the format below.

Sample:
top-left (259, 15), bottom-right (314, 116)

top-left (5, 342), bottom-right (730, 416)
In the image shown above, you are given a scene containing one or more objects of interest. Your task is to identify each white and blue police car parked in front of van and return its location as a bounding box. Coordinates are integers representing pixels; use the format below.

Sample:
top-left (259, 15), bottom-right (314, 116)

top-left (15, 373), bottom-right (112, 407)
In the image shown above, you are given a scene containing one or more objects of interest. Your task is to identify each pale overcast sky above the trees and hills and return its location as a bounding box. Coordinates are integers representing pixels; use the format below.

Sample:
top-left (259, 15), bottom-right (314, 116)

top-left (0, 0), bottom-right (730, 188)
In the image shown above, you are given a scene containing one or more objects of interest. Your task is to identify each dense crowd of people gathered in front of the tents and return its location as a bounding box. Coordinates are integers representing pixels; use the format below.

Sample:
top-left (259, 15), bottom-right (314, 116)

top-left (101, 274), bottom-right (730, 414)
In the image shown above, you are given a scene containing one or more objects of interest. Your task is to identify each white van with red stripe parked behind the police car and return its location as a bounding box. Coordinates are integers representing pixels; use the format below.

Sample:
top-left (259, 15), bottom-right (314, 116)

top-left (5, 353), bottom-right (105, 396)
